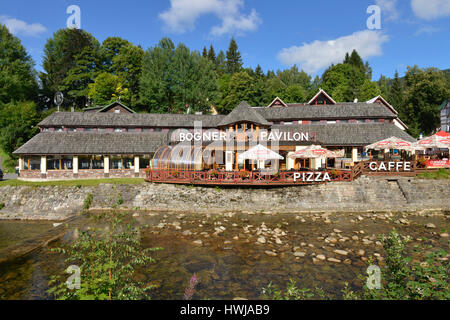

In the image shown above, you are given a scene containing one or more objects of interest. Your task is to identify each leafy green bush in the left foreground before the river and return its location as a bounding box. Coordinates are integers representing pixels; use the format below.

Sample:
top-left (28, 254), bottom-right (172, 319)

top-left (48, 211), bottom-right (161, 300)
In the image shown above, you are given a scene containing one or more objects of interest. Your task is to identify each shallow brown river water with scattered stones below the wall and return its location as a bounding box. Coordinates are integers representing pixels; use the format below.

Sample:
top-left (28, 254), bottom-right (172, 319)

top-left (0, 213), bottom-right (448, 299)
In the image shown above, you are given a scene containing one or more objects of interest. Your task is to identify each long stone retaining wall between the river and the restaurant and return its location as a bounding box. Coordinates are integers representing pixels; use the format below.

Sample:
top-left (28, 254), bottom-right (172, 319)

top-left (0, 177), bottom-right (450, 220)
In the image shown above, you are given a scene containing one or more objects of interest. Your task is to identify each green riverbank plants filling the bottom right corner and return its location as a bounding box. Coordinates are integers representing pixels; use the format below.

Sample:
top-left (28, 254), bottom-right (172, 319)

top-left (262, 229), bottom-right (450, 300)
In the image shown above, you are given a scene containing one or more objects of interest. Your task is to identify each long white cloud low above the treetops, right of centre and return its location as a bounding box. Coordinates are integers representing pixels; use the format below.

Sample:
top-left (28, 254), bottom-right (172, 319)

top-left (278, 30), bottom-right (389, 73)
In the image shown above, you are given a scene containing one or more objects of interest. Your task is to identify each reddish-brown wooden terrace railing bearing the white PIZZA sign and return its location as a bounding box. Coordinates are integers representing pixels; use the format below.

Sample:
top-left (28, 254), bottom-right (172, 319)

top-left (146, 170), bottom-right (353, 185)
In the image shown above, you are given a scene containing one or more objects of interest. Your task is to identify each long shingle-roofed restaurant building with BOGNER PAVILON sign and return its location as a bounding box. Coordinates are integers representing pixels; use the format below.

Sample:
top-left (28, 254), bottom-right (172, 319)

top-left (14, 90), bottom-right (415, 180)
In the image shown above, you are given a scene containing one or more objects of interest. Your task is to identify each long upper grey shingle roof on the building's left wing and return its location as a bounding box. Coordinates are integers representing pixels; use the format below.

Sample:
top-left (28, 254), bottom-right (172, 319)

top-left (38, 112), bottom-right (225, 128)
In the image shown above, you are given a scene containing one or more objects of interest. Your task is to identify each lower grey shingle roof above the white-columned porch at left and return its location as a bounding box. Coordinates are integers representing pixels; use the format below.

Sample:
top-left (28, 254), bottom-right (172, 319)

top-left (14, 132), bottom-right (168, 155)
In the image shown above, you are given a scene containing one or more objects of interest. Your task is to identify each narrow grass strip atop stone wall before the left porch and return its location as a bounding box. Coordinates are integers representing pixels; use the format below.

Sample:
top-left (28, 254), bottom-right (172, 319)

top-left (0, 178), bottom-right (145, 188)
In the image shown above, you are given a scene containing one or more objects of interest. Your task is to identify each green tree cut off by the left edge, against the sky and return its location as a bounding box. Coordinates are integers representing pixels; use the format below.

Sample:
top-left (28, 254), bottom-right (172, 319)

top-left (0, 24), bottom-right (38, 107)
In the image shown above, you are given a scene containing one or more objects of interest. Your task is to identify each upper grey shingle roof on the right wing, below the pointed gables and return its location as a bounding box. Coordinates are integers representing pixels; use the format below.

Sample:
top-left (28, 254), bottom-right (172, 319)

top-left (254, 102), bottom-right (396, 121)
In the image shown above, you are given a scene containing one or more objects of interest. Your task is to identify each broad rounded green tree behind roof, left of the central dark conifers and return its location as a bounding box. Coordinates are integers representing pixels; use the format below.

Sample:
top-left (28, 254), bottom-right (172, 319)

top-left (140, 39), bottom-right (217, 113)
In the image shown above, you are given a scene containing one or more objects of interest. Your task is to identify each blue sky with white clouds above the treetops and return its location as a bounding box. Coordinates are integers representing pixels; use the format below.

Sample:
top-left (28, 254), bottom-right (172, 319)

top-left (0, 0), bottom-right (450, 80)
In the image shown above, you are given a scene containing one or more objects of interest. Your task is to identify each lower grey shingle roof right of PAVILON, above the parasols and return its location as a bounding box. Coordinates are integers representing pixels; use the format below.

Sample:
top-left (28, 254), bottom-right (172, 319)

top-left (272, 123), bottom-right (416, 146)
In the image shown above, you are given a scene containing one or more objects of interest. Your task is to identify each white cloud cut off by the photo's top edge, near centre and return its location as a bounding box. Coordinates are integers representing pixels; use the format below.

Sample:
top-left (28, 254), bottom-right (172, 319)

top-left (159, 0), bottom-right (261, 36)
